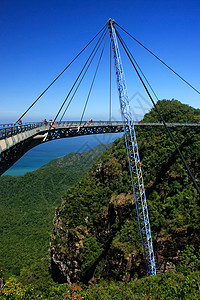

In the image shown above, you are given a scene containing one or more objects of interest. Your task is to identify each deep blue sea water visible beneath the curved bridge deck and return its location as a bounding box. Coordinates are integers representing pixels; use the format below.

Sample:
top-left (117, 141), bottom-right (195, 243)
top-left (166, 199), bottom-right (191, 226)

top-left (4, 133), bottom-right (122, 176)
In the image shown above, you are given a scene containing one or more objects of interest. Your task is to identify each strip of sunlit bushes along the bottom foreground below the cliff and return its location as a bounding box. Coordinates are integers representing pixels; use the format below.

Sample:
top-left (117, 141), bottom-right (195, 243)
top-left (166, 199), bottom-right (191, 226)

top-left (0, 258), bottom-right (200, 300)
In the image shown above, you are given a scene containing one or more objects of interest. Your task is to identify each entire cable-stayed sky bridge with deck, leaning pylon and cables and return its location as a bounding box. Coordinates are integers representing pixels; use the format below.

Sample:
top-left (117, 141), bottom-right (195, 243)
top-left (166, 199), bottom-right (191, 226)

top-left (0, 19), bottom-right (200, 275)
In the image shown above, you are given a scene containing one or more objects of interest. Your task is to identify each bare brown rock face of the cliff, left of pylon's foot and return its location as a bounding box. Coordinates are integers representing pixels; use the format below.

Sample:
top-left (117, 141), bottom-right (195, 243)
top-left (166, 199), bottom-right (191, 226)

top-left (50, 194), bottom-right (145, 284)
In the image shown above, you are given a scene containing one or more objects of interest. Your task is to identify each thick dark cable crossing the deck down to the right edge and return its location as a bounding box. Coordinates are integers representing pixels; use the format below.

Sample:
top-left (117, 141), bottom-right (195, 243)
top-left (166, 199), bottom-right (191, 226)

top-left (115, 28), bottom-right (200, 194)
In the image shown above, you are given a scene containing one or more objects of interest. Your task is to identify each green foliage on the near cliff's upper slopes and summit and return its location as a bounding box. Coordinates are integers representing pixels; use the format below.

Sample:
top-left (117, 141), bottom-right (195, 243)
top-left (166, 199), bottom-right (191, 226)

top-left (50, 100), bottom-right (200, 280)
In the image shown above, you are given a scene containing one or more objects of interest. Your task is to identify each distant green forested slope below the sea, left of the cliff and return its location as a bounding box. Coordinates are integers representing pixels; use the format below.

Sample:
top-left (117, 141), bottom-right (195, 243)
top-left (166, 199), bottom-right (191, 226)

top-left (0, 145), bottom-right (108, 278)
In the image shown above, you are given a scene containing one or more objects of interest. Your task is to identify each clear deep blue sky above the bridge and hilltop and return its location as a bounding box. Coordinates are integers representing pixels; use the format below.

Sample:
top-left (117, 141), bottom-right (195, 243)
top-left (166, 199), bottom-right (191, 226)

top-left (0, 0), bottom-right (200, 123)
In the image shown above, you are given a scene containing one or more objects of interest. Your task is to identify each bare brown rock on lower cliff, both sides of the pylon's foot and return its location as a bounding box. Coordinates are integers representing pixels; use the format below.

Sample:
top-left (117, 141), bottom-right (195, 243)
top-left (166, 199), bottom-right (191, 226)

top-left (50, 203), bottom-right (200, 284)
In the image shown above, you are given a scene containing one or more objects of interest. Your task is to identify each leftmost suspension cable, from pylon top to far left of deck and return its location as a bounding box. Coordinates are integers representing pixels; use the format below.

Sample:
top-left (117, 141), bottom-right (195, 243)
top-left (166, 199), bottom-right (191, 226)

top-left (16, 25), bottom-right (107, 123)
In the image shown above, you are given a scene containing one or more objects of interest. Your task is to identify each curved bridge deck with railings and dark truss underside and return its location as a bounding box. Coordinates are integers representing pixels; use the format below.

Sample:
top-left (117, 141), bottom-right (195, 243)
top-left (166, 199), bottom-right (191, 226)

top-left (0, 121), bottom-right (200, 175)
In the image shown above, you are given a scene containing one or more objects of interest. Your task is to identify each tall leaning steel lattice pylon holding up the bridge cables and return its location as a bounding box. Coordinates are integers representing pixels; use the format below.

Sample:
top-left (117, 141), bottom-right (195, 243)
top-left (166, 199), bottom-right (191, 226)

top-left (108, 19), bottom-right (156, 275)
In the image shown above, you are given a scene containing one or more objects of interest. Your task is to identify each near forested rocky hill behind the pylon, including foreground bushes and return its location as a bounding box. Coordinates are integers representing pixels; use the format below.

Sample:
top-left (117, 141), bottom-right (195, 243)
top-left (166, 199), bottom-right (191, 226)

top-left (1, 100), bottom-right (200, 300)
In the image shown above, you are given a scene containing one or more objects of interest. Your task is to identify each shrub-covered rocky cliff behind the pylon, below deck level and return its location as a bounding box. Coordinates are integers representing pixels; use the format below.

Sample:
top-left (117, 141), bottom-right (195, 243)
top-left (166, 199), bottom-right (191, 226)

top-left (49, 100), bottom-right (200, 284)
